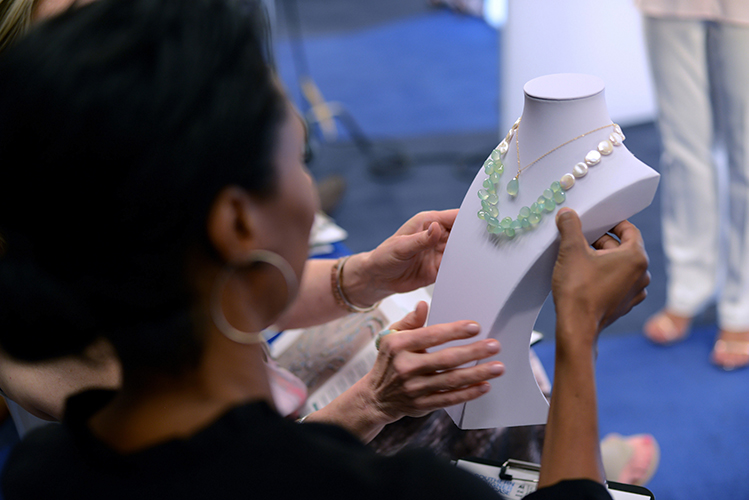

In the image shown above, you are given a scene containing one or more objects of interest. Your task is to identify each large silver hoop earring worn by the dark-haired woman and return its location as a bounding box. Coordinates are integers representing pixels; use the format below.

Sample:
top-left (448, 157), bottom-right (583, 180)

top-left (211, 250), bottom-right (299, 344)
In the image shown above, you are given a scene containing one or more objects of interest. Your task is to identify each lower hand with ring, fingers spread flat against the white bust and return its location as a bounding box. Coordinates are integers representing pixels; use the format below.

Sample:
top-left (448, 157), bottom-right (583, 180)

top-left (364, 302), bottom-right (504, 423)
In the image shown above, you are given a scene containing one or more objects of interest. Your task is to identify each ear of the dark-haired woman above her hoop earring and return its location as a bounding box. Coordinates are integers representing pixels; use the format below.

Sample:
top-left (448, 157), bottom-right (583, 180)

top-left (207, 186), bottom-right (256, 262)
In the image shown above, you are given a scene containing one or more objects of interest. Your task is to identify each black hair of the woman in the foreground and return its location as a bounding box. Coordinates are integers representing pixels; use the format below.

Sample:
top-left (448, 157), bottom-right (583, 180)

top-left (0, 0), bottom-right (286, 372)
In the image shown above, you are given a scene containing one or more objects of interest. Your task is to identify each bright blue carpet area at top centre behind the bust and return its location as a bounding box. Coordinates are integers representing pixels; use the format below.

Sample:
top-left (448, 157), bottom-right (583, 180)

top-left (276, 11), bottom-right (499, 137)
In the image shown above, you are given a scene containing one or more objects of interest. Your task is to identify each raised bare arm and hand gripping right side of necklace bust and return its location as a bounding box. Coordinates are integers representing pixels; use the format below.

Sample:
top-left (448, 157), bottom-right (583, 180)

top-left (539, 209), bottom-right (650, 488)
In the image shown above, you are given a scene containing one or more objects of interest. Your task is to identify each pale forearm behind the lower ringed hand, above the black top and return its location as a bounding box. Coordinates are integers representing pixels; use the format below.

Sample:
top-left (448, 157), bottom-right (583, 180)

top-left (305, 377), bottom-right (392, 443)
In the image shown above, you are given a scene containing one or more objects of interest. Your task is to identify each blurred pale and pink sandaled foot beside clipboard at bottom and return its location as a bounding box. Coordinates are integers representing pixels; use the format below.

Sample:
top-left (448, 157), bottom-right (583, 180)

top-left (601, 433), bottom-right (661, 486)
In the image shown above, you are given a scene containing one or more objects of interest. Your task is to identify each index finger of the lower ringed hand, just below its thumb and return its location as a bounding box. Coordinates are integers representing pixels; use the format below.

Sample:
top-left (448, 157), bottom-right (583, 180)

top-left (380, 321), bottom-right (481, 354)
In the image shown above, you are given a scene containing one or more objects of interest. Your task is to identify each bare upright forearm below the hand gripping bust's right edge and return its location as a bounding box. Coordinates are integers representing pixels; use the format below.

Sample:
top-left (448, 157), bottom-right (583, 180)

top-left (539, 322), bottom-right (605, 487)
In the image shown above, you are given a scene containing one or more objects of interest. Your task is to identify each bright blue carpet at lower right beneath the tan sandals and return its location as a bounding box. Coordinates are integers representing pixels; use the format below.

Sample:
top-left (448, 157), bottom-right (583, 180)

top-left (536, 327), bottom-right (749, 500)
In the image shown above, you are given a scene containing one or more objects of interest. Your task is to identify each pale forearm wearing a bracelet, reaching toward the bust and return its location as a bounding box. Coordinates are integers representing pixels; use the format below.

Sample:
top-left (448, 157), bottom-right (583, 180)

top-left (276, 253), bottom-right (389, 329)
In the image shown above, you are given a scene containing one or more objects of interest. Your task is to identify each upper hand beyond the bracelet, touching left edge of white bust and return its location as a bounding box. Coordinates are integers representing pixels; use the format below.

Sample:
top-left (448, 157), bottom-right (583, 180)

top-left (344, 209), bottom-right (458, 305)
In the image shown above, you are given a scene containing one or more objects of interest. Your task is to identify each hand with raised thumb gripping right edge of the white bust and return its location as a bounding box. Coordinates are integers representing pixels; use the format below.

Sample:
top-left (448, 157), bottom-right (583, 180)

top-left (552, 208), bottom-right (650, 343)
